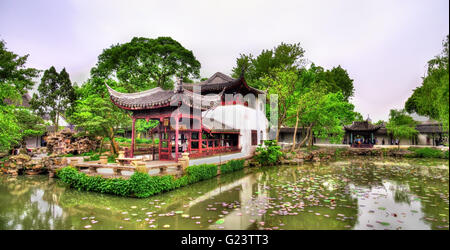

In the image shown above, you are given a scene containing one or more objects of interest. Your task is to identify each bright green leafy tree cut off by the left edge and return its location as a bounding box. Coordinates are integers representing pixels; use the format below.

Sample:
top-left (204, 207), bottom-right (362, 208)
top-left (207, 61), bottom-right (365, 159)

top-left (0, 40), bottom-right (39, 151)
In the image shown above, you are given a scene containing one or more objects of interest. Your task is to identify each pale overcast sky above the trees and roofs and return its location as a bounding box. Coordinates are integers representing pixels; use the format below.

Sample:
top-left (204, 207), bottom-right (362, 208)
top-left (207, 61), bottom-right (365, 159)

top-left (0, 0), bottom-right (449, 121)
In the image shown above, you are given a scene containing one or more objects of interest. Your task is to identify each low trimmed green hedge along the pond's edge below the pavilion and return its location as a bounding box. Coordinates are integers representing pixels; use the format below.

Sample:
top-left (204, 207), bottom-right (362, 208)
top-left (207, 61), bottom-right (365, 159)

top-left (56, 160), bottom-right (245, 198)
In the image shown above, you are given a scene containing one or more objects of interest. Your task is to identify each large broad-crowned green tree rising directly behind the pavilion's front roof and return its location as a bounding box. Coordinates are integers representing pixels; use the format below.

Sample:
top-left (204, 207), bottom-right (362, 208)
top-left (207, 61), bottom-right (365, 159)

top-left (91, 37), bottom-right (201, 92)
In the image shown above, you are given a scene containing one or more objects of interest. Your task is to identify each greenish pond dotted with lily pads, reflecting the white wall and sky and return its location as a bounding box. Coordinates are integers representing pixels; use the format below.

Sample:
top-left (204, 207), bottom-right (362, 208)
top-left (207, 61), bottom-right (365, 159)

top-left (0, 158), bottom-right (449, 230)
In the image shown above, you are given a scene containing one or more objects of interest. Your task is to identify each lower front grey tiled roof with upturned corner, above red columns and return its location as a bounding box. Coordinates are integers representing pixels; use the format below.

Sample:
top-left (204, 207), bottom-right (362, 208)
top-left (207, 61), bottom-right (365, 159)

top-left (106, 84), bottom-right (224, 110)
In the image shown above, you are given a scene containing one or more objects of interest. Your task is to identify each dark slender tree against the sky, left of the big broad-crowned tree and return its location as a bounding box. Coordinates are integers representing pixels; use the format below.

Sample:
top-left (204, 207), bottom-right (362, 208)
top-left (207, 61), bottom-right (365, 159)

top-left (30, 66), bottom-right (76, 132)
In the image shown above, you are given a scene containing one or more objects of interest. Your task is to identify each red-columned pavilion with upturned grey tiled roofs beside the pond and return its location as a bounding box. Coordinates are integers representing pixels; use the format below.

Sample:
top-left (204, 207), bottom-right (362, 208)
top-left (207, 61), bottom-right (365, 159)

top-left (107, 72), bottom-right (264, 161)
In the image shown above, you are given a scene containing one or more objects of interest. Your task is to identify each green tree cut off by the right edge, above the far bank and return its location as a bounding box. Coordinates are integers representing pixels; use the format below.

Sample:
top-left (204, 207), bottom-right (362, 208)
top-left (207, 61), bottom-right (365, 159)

top-left (405, 35), bottom-right (449, 131)
